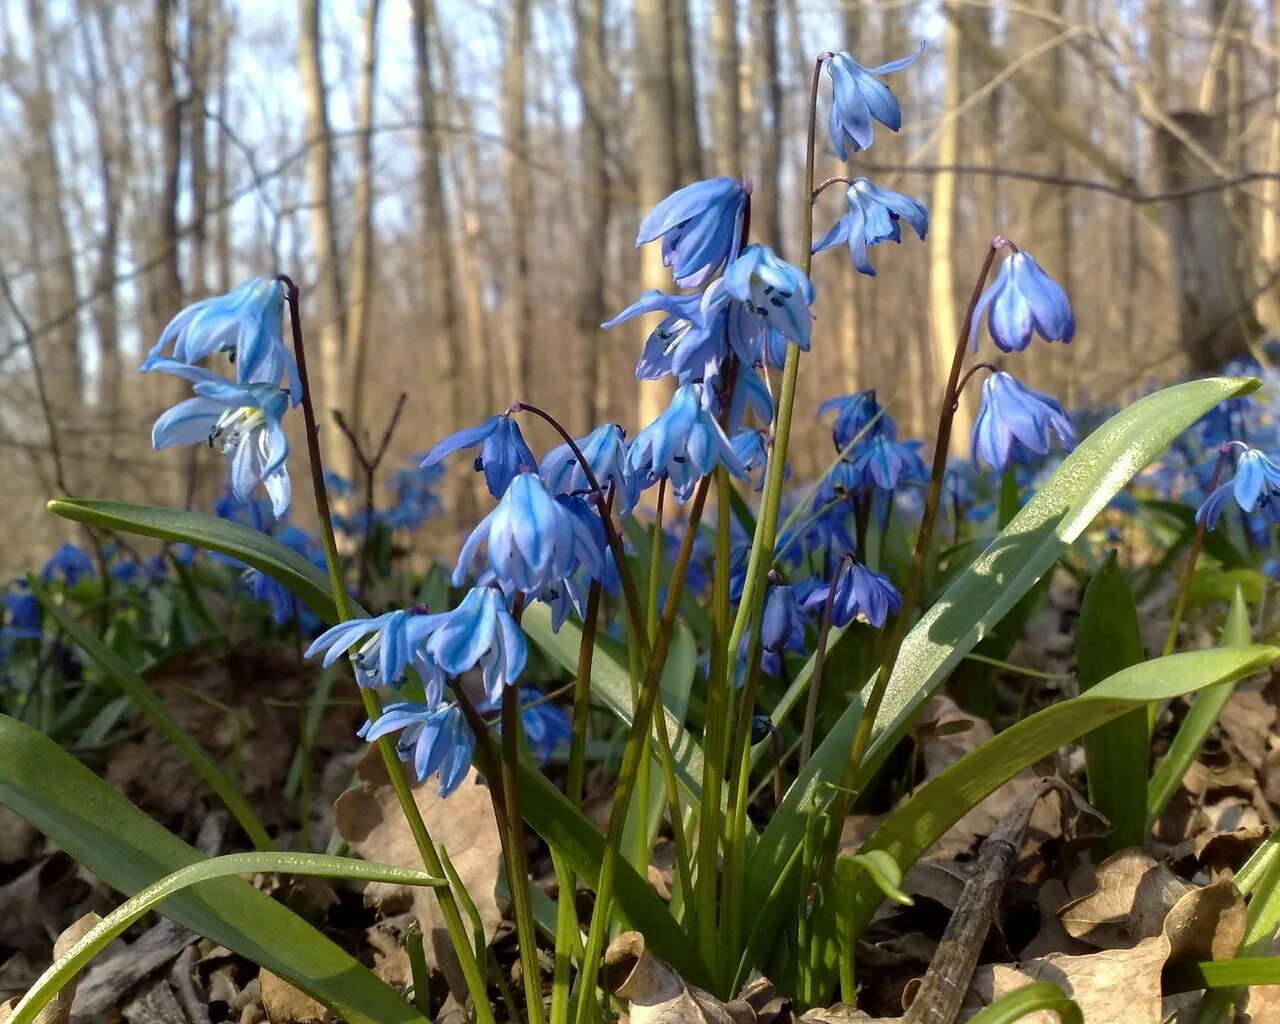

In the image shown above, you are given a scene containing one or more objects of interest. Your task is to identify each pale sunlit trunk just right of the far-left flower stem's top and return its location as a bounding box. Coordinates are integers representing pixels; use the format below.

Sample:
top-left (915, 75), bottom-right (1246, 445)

top-left (298, 0), bottom-right (346, 417)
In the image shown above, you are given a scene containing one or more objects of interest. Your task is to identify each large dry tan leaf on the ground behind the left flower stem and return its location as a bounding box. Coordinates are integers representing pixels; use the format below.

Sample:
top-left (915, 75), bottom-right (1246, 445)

top-left (334, 749), bottom-right (502, 993)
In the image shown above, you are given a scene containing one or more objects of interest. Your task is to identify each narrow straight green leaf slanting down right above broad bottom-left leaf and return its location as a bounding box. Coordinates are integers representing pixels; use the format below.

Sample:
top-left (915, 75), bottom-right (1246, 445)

top-left (27, 575), bottom-right (275, 850)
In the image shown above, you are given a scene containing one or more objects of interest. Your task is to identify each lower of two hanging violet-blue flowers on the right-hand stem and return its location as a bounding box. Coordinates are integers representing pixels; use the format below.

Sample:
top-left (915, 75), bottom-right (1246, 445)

top-left (973, 370), bottom-right (1075, 472)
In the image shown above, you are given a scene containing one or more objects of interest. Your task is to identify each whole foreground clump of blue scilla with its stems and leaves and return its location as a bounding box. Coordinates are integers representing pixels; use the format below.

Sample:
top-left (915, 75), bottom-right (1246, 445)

top-left (15, 36), bottom-right (1280, 1024)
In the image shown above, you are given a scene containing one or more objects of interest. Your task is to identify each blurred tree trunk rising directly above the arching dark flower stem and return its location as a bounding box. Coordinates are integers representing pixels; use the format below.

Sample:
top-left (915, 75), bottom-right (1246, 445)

top-left (502, 0), bottom-right (534, 398)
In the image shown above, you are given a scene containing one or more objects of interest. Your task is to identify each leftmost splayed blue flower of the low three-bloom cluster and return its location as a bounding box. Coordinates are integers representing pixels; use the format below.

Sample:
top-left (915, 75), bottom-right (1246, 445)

top-left (306, 608), bottom-right (444, 701)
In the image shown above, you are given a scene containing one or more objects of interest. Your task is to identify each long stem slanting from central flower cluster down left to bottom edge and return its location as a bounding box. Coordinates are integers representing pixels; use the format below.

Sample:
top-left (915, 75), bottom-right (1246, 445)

top-left (573, 476), bottom-right (710, 1024)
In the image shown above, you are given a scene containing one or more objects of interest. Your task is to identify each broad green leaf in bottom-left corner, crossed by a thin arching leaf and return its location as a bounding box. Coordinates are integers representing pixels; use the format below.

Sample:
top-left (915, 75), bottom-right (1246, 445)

top-left (0, 716), bottom-right (422, 1024)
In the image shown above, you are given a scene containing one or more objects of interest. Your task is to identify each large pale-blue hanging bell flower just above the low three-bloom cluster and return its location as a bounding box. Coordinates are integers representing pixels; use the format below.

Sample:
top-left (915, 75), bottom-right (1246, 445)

top-left (453, 472), bottom-right (603, 593)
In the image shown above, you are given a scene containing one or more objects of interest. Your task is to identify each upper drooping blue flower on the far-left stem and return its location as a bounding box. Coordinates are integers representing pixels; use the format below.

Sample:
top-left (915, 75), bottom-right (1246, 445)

top-left (141, 278), bottom-right (302, 404)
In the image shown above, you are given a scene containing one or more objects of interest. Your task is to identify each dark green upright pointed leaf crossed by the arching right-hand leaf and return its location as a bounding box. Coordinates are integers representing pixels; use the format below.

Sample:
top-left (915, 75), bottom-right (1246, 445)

top-left (1075, 552), bottom-right (1149, 856)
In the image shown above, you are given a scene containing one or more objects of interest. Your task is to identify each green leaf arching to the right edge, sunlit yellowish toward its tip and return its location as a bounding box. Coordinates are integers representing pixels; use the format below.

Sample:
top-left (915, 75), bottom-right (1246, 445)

top-left (837, 646), bottom-right (1280, 952)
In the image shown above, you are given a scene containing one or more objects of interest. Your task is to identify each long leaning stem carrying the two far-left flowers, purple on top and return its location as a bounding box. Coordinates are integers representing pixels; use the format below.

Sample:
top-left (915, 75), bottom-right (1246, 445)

top-left (279, 274), bottom-right (495, 1024)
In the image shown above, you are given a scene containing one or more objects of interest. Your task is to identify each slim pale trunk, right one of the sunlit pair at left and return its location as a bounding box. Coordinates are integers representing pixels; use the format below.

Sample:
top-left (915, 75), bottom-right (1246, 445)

top-left (347, 0), bottom-right (381, 448)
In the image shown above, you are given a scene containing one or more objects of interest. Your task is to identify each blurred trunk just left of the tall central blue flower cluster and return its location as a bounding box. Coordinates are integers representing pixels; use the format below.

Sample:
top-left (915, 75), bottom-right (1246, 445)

top-left (573, 0), bottom-right (612, 426)
